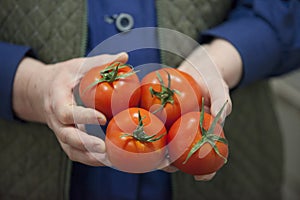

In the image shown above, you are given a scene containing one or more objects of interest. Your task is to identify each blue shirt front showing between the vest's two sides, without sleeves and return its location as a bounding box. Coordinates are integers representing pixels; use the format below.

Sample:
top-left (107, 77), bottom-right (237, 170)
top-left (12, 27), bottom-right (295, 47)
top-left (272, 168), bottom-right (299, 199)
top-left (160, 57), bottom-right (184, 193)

top-left (70, 0), bottom-right (171, 200)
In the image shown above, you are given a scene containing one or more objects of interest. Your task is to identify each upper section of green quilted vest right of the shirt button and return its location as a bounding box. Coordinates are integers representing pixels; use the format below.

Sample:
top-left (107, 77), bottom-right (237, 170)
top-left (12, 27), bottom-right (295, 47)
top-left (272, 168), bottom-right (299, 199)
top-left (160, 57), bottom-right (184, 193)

top-left (156, 0), bottom-right (232, 66)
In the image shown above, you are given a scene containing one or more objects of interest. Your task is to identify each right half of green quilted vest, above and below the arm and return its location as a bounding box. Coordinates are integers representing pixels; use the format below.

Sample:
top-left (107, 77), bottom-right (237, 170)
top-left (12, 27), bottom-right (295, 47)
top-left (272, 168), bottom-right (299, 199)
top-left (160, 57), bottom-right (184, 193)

top-left (157, 3), bottom-right (283, 197)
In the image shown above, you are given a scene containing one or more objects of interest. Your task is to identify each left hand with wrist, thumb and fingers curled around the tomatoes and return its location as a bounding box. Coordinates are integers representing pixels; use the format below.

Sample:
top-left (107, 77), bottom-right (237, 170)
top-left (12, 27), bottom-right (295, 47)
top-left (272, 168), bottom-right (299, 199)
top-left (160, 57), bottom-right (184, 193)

top-left (13, 53), bottom-right (128, 166)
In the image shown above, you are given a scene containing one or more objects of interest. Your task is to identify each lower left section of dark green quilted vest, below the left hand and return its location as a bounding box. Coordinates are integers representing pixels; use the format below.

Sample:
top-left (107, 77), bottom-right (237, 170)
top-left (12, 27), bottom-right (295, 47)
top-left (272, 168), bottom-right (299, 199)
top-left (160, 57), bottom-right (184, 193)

top-left (0, 120), bottom-right (70, 200)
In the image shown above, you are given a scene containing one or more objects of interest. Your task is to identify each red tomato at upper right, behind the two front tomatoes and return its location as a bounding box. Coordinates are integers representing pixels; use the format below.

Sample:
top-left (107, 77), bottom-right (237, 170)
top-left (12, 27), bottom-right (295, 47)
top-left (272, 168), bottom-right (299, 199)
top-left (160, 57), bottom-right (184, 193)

top-left (140, 68), bottom-right (202, 128)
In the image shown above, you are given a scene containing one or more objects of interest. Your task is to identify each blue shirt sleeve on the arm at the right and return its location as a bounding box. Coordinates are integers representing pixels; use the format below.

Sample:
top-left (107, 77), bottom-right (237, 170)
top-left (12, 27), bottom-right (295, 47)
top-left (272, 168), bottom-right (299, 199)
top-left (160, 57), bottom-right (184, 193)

top-left (202, 0), bottom-right (300, 86)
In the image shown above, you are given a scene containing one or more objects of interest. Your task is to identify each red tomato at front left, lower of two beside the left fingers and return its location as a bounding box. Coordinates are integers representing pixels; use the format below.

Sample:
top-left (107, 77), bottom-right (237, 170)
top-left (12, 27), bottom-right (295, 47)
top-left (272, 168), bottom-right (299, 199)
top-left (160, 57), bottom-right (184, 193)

top-left (105, 108), bottom-right (167, 173)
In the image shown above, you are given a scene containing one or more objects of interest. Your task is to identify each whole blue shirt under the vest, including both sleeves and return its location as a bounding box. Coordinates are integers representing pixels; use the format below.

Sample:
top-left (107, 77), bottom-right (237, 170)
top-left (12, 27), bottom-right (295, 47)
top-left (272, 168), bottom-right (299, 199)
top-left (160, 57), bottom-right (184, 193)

top-left (0, 0), bottom-right (300, 199)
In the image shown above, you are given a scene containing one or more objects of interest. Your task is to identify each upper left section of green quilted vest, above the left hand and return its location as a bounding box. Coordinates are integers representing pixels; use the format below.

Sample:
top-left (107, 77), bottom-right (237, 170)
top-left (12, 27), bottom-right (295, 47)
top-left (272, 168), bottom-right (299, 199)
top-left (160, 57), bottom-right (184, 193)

top-left (0, 0), bottom-right (87, 63)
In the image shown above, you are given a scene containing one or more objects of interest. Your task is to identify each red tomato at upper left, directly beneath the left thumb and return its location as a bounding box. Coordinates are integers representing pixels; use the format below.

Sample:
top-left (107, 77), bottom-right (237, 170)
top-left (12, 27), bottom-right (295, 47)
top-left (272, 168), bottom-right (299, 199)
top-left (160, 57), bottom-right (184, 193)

top-left (79, 62), bottom-right (141, 119)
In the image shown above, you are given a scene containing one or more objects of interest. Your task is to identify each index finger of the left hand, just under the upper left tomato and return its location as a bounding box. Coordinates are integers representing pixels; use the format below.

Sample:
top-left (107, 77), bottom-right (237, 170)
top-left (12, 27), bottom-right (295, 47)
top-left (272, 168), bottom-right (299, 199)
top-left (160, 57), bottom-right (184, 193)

top-left (54, 104), bottom-right (106, 125)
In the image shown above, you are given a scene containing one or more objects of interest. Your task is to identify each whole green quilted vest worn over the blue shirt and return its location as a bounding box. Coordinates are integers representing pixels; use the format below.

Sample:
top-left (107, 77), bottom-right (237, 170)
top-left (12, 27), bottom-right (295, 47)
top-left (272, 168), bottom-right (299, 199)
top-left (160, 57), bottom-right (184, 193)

top-left (0, 0), bottom-right (283, 200)
